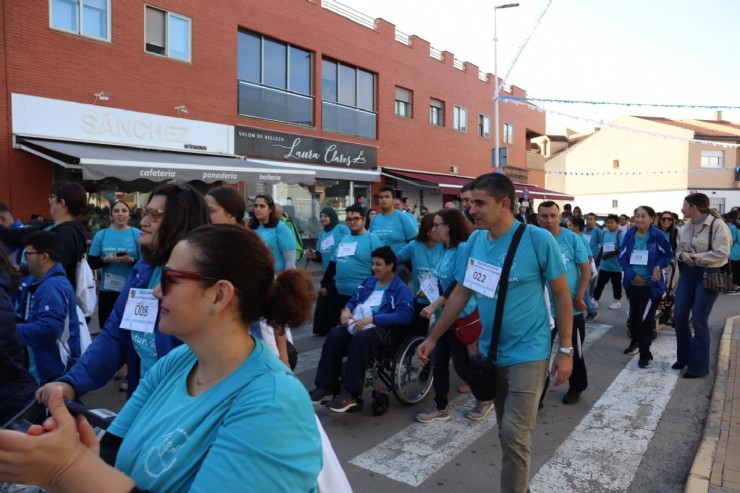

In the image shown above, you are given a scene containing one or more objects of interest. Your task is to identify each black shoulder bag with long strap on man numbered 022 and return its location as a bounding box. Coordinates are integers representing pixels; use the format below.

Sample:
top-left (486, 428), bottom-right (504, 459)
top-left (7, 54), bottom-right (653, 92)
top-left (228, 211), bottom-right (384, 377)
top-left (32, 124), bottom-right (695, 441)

top-left (468, 224), bottom-right (526, 401)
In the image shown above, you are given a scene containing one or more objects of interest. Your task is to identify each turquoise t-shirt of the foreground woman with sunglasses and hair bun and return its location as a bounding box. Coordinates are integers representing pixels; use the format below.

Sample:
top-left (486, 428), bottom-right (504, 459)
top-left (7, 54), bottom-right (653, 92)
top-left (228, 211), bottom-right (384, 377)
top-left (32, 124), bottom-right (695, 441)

top-left (108, 340), bottom-right (322, 492)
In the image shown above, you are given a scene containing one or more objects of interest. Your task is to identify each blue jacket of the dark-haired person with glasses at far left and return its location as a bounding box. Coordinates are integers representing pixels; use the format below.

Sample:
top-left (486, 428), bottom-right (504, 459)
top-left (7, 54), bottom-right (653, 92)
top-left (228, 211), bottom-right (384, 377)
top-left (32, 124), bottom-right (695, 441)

top-left (16, 263), bottom-right (80, 385)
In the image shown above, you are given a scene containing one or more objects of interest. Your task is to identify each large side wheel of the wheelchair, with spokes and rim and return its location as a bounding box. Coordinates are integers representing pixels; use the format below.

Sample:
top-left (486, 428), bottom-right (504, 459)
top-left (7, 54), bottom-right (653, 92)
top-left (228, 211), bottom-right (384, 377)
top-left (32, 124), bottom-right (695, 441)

top-left (391, 335), bottom-right (434, 406)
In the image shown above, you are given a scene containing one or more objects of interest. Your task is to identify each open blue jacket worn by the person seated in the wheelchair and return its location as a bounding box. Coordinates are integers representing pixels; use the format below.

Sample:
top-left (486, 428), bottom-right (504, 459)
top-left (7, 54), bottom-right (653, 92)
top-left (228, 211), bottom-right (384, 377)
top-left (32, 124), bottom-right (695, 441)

top-left (346, 276), bottom-right (414, 327)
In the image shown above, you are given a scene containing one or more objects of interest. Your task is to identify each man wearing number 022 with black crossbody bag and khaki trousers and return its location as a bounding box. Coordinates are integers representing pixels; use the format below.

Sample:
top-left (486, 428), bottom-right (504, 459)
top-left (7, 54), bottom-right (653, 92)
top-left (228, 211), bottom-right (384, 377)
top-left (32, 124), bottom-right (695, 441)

top-left (417, 173), bottom-right (573, 493)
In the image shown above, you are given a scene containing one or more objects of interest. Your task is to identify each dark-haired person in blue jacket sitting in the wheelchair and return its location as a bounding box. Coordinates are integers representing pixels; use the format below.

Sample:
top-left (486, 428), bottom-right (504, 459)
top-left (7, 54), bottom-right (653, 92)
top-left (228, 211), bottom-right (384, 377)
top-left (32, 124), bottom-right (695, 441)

top-left (311, 246), bottom-right (414, 413)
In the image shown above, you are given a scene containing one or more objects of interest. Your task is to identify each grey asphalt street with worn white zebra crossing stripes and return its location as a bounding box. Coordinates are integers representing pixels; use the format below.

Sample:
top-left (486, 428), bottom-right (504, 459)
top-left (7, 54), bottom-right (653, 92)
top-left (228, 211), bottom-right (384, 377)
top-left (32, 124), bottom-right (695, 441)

top-left (86, 294), bottom-right (737, 492)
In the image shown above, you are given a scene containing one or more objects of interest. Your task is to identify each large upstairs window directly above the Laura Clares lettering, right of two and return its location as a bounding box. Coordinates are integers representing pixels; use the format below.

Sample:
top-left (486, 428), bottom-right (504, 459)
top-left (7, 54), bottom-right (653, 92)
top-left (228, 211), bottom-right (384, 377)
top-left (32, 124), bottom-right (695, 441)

top-left (321, 59), bottom-right (377, 139)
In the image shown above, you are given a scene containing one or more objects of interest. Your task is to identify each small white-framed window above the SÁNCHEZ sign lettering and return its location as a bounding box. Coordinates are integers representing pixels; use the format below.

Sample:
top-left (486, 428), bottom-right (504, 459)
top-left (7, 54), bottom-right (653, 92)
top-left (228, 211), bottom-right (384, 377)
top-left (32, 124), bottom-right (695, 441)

top-left (144, 5), bottom-right (191, 62)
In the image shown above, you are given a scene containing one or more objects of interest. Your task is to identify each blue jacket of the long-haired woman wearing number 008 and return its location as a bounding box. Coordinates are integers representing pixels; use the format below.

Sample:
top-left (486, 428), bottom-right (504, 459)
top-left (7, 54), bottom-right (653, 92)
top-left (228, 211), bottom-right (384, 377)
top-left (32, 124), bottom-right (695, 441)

top-left (59, 259), bottom-right (182, 396)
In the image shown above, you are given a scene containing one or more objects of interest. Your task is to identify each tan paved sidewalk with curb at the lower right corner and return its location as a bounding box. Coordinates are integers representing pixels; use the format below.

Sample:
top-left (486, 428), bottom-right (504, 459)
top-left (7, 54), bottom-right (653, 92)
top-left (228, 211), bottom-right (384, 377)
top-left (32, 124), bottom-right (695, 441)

top-left (685, 316), bottom-right (740, 493)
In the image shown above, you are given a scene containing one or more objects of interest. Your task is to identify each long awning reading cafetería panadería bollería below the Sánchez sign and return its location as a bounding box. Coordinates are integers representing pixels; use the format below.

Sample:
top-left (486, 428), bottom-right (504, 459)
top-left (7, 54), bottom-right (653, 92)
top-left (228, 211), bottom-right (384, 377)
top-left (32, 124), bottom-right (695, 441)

top-left (16, 137), bottom-right (316, 184)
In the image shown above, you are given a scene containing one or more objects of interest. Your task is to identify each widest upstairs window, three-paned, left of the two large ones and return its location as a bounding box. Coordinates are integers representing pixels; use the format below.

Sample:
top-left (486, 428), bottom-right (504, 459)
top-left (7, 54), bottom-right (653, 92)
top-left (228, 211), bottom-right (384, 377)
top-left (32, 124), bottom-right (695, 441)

top-left (237, 31), bottom-right (314, 127)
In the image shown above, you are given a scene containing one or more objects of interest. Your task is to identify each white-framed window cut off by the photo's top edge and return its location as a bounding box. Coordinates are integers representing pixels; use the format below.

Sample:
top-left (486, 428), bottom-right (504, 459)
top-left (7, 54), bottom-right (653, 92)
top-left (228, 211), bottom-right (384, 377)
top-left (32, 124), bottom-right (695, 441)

top-left (49, 0), bottom-right (110, 41)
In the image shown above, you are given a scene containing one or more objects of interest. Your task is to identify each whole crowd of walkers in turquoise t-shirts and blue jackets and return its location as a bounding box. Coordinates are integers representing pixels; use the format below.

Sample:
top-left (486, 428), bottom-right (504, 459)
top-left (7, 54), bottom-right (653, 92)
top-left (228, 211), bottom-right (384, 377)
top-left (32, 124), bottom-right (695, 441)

top-left (0, 178), bottom-right (740, 492)
